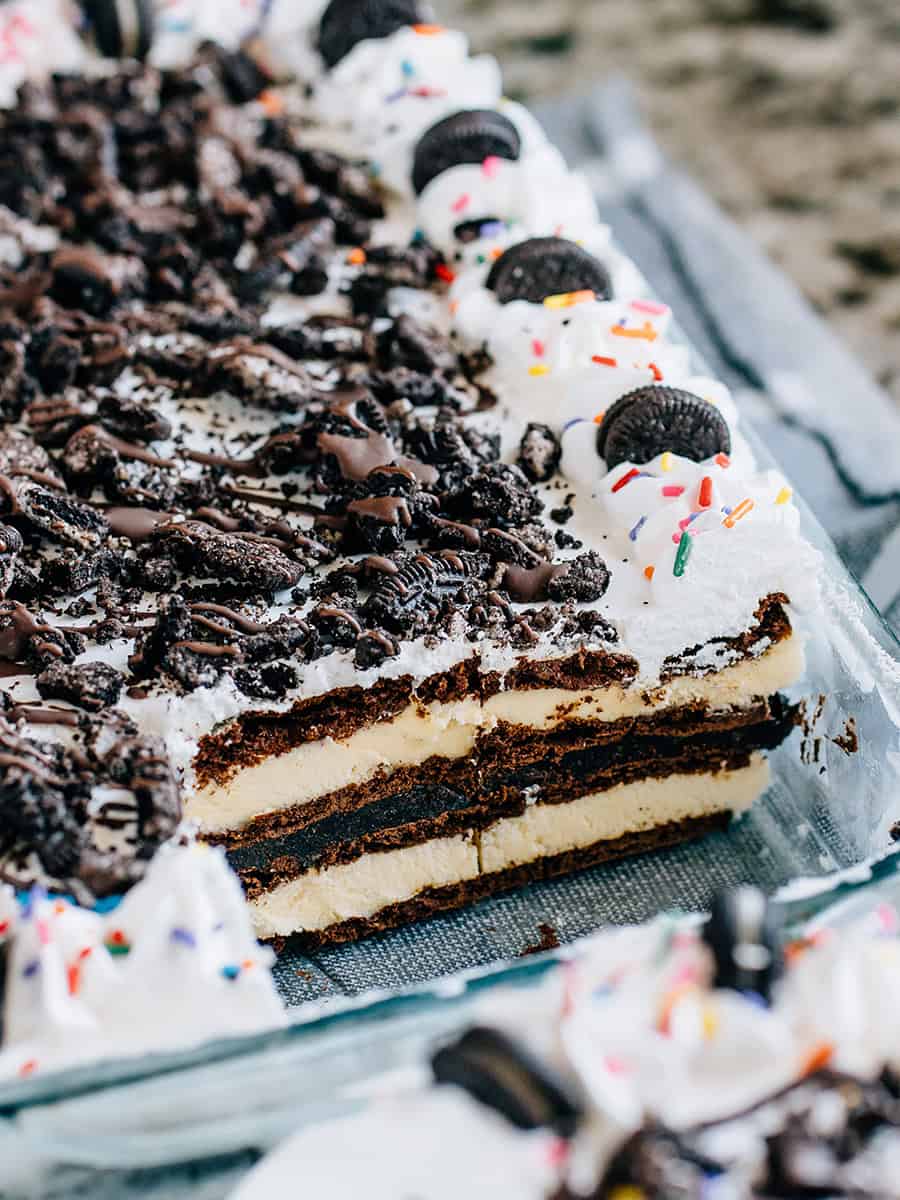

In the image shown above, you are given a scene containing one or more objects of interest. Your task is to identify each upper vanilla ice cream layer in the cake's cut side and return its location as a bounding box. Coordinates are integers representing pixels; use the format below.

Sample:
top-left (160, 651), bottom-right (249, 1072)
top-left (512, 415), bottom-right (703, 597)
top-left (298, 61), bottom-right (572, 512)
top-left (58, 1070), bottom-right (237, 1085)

top-left (192, 637), bottom-right (804, 834)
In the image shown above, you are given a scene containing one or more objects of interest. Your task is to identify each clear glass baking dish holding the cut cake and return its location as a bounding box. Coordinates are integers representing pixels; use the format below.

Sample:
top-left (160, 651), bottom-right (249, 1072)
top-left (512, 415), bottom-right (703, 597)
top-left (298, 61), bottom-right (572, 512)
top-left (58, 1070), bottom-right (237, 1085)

top-left (0, 72), bottom-right (900, 1196)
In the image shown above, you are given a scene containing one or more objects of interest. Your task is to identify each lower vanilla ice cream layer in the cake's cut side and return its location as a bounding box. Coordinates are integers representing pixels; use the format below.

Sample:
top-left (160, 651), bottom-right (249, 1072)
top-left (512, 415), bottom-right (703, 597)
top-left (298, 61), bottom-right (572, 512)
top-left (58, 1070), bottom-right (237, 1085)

top-left (251, 755), bottom-right (769, 938)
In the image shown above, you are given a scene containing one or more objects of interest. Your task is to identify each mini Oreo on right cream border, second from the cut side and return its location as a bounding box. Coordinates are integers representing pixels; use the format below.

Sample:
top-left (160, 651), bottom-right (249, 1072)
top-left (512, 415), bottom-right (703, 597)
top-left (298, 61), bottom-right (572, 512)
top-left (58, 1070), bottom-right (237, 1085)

top-left (486, 238), bottom-right (612, 304)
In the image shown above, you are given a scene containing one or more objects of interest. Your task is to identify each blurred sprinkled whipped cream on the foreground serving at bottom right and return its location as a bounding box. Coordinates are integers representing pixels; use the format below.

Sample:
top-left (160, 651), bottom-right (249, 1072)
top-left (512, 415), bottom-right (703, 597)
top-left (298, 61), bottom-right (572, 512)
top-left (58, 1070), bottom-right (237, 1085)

top-left (232, 905), bottom-right (900, 1200)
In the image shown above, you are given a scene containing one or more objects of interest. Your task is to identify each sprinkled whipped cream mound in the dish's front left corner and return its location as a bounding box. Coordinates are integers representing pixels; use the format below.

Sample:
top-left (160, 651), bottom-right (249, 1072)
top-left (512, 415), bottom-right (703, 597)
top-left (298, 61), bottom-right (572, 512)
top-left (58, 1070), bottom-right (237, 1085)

top-left (0, 845), bottom-right (284, 1079)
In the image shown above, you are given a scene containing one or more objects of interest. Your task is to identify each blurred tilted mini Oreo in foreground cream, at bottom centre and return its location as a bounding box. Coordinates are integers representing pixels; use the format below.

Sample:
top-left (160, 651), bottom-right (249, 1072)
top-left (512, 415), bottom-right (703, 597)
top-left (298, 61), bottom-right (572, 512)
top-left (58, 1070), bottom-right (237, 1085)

top-left (431, 1026), bottom-right (582, 1138)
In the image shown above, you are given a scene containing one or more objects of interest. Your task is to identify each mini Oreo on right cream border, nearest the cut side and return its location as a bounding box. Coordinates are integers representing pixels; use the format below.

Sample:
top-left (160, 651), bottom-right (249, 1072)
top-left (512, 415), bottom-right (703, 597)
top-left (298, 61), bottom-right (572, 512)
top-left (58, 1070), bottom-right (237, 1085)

top-left (596, 385), bottom-right (731, 470)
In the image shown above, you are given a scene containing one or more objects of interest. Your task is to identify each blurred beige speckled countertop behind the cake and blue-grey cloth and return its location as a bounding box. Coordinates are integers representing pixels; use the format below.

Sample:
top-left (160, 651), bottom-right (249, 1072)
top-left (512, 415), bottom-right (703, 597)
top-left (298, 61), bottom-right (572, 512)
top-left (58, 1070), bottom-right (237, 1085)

top-left (438, 0), bottom-right (900, 407)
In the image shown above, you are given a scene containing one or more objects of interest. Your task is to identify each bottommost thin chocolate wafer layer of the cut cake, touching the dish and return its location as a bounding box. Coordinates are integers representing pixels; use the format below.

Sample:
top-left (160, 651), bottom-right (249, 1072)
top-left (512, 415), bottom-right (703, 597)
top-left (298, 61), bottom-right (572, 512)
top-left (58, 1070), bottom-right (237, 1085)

top-left (259, 812), bottom-right (732, 950)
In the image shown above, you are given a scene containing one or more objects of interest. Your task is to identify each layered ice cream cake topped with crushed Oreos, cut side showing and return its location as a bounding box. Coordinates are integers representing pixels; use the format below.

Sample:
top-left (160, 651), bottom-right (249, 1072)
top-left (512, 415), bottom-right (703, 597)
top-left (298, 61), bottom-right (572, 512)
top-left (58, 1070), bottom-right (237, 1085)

top-left (0, 7), bottom-right (817, 944)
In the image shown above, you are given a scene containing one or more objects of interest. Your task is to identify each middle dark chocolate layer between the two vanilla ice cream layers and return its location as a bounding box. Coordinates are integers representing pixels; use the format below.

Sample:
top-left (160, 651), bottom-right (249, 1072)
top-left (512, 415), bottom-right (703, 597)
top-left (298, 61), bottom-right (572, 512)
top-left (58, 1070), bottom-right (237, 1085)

top-left (230, 696), bottom-right (796, 896)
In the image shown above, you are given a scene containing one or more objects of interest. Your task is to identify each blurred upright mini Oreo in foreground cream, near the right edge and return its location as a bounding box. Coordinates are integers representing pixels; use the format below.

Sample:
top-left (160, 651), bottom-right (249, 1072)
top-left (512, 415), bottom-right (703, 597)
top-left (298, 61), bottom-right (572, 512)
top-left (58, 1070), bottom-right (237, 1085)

top-left (703, 887), bottom-right (782, 1000)
